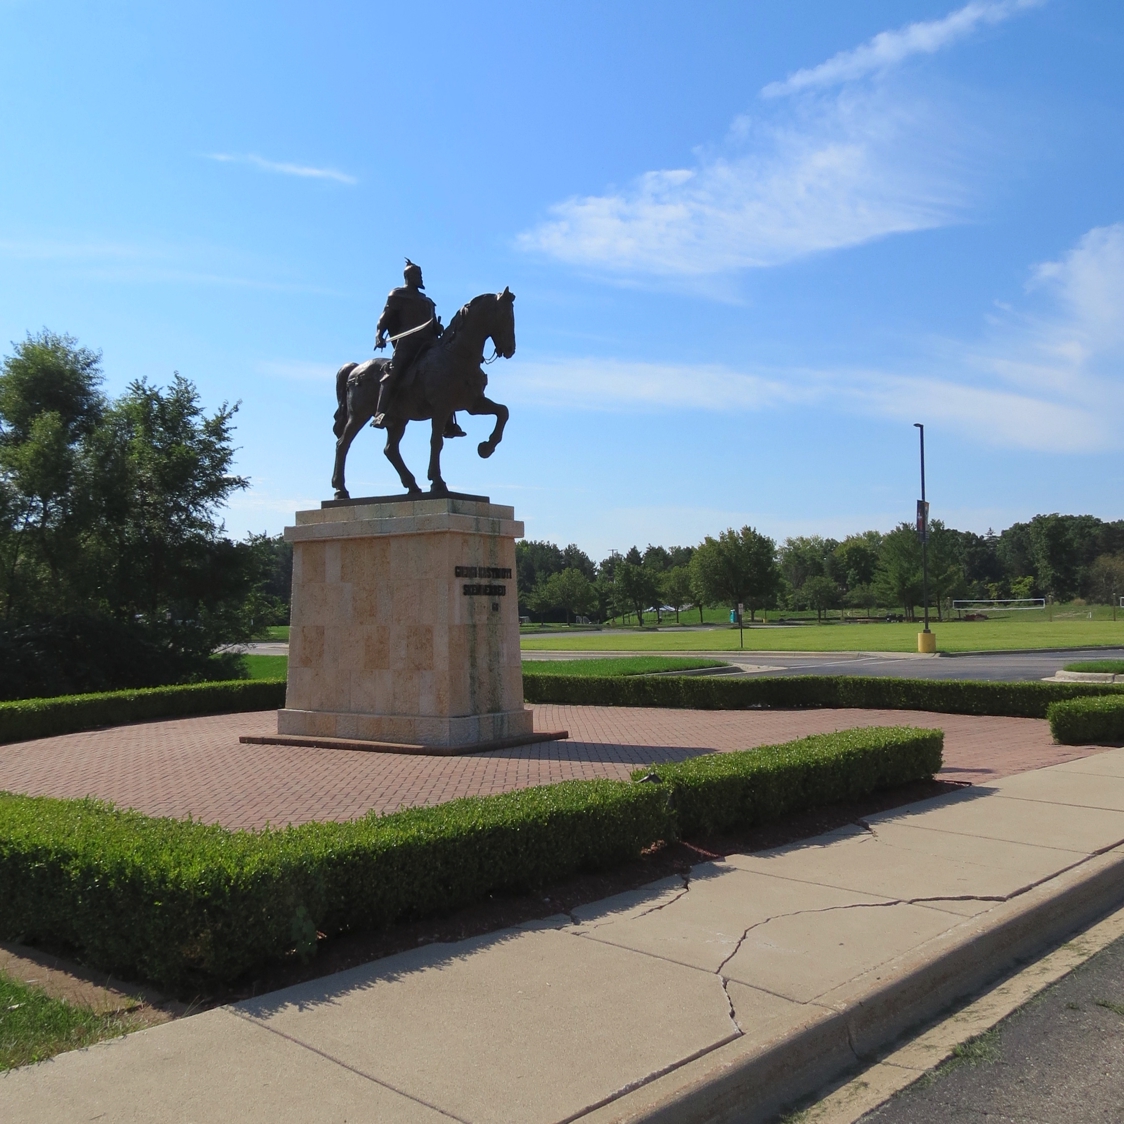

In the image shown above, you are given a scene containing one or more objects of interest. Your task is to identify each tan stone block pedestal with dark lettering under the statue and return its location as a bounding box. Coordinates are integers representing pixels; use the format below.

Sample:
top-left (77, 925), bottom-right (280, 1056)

top-left (278, 497), bottom-right (533, 749)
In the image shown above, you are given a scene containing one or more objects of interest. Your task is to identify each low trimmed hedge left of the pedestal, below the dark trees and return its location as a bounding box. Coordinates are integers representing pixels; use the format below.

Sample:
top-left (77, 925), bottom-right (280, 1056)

top-left (0, 679), bottom-right (285, 743)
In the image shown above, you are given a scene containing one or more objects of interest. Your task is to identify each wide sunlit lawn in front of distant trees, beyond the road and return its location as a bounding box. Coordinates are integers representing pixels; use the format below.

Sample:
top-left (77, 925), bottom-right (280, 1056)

top-left (522, 617), bottom-right (1124, 652)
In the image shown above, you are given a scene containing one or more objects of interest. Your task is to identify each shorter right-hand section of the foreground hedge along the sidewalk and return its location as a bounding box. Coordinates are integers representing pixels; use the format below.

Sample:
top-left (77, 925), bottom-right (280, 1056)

top-left (633, 726), bottom-right (944, 839)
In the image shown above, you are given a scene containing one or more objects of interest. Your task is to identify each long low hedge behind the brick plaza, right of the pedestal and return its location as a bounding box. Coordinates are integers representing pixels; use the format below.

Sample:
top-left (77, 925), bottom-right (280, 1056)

top-left (523, 676), bottom-right (1124, 718)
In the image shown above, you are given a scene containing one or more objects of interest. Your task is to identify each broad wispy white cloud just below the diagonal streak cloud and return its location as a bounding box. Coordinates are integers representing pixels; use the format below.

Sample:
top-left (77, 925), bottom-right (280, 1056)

top-left (518, 97), bottom-right (964, 278)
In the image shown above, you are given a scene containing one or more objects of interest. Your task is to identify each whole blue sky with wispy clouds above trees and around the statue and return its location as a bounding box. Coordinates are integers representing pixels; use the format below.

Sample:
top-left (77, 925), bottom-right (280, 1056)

top-left (0, 0), bottom-right (1124, 558)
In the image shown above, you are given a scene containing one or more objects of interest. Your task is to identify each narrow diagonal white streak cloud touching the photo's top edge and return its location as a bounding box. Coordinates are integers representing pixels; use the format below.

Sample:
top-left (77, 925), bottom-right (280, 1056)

top-left (761, 0), bottom-right (1044, 98)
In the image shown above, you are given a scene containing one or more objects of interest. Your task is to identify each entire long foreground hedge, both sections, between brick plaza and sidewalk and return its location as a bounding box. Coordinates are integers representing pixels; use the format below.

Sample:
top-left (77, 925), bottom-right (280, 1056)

top-left (0, 728), bottom-right (941, 992)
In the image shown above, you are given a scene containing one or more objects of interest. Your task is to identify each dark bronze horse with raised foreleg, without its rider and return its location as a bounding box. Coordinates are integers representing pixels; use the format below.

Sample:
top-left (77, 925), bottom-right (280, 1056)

top-left (332, 289), bottom-right (515, 499)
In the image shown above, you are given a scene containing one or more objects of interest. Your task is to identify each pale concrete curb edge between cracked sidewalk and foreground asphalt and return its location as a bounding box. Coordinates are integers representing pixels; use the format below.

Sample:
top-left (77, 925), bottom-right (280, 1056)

top-left (574, 843), bottom-right (1124, 1124)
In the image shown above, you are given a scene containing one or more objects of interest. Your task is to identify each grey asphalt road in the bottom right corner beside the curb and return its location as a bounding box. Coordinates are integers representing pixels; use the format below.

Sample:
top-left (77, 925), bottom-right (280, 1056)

top-left (861, 939), bottom-right (1124, 1124)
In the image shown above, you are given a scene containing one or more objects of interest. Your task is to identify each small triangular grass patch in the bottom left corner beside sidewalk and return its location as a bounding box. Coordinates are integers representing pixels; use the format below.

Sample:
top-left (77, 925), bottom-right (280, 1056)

top-left (0, 972), bottom-right (134, 1070)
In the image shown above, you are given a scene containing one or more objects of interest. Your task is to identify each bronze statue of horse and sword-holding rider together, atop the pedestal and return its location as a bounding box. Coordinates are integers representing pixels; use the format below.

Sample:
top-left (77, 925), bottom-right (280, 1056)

top-left (332, 257), bottom-right (515, 499)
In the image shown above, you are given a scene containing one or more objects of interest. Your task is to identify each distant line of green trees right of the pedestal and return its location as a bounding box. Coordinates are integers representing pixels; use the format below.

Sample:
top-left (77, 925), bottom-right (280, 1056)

top-left (516, 514), bottom-right (1124, 625)
